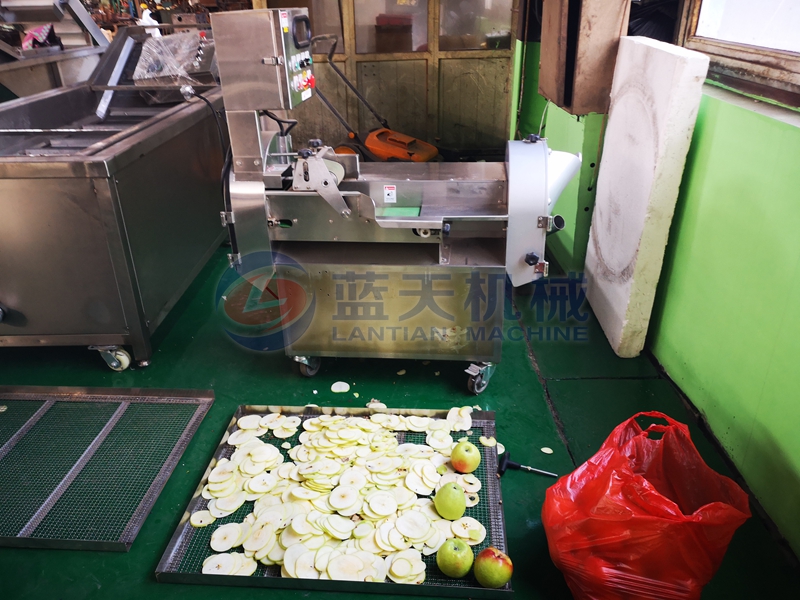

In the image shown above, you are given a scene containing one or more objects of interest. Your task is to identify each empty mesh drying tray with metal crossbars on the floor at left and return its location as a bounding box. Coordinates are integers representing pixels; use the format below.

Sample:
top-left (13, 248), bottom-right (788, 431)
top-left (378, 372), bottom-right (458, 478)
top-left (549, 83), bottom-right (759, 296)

top-left (0, 387), bottom-right (214, 552)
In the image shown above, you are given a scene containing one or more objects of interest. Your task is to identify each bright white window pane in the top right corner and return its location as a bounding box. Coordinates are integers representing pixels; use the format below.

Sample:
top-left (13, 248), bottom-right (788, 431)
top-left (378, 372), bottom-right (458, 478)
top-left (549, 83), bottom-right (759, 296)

top-left (695, 0), bottom-right (800, 52)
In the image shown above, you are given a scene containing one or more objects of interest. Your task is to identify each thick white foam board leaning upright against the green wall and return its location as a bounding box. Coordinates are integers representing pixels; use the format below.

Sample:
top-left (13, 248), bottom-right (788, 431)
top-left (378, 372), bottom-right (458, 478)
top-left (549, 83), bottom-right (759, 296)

top-left (586, 37), bottom-right (708, 357)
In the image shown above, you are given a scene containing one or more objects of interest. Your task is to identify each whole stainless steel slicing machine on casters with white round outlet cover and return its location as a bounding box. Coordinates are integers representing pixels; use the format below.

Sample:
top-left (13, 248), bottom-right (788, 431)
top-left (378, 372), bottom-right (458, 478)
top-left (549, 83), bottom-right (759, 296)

top-left (211, 9), bottom-right (580, 393)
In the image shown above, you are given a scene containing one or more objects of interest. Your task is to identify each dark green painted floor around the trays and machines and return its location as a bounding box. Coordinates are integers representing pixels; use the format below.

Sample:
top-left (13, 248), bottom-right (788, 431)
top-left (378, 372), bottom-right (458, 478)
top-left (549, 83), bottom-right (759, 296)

top-left (0, 249), bottom-right (800, 600)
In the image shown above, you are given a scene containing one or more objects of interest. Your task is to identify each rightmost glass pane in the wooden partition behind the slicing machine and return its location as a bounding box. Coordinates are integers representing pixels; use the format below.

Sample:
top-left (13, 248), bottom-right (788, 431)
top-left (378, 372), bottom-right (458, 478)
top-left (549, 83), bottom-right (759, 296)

top-left (439, 0), bottom-right (512, 50)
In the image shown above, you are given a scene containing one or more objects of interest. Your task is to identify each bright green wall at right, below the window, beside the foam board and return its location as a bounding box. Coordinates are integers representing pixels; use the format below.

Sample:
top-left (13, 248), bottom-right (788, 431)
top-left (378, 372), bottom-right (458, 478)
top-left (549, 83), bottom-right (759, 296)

top-left (648, 95), bottom-right (800, 554)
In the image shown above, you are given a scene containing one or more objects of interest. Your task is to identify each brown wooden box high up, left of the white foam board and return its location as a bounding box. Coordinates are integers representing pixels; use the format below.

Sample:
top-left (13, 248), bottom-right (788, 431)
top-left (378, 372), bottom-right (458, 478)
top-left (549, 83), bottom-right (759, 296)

top-left (539, 0), bottom-right (630, 115)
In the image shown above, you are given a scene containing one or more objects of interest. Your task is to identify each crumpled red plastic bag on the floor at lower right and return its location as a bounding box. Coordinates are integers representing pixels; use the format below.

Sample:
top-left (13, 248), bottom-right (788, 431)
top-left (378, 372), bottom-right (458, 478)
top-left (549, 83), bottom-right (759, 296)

top-left (542, 412), bottom-right (750, 600)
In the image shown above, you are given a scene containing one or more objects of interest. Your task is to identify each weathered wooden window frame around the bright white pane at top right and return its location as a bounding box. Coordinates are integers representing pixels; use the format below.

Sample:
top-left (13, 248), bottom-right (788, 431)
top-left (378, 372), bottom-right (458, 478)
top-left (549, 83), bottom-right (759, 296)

top-left (676, 0), bottom-right (800, 106)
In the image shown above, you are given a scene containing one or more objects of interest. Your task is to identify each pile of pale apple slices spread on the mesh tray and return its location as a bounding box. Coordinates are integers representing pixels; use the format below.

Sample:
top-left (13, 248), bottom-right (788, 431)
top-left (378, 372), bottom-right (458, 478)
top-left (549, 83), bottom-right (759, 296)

top-left (190, 407), bottom-right (486, 584)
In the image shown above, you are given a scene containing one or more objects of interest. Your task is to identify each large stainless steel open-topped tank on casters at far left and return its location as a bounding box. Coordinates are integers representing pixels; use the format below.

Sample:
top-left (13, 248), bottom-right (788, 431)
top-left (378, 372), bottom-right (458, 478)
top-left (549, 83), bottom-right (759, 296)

top-left (0, 27), bottom-right (225, 370)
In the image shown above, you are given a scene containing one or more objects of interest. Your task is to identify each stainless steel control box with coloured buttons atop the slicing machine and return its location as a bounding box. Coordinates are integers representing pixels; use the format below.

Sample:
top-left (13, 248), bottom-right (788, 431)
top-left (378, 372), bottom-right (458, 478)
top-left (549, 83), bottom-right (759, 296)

top-left (211, 8), bottom-right (316, 111)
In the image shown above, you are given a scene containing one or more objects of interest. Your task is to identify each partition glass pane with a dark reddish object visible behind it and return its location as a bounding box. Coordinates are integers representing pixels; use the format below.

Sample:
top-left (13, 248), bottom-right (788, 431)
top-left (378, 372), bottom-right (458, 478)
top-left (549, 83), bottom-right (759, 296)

top-left (355, 0), bottom-right (428, 54)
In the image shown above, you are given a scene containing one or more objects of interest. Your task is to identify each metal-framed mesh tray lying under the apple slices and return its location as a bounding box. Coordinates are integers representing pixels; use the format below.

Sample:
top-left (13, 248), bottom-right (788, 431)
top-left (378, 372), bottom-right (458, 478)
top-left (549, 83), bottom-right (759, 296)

top-left (156, 405), bottom-right (512, 598)
